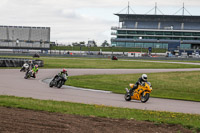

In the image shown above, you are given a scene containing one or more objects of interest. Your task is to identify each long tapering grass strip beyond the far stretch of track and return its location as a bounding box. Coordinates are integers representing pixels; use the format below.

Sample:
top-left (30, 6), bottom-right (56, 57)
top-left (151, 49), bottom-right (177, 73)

top-left (0, 56), bottom-right (200, 69)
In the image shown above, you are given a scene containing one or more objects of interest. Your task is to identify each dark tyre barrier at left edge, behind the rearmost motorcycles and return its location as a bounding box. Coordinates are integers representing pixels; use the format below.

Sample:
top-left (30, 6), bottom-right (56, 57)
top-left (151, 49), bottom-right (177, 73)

top-left (0, 58), bottom-right (44, 67)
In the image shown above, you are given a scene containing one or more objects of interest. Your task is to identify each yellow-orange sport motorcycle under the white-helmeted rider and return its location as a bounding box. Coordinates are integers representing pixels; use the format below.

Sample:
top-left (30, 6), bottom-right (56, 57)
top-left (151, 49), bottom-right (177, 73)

top-left (124, 82), bottom-right (152, 103)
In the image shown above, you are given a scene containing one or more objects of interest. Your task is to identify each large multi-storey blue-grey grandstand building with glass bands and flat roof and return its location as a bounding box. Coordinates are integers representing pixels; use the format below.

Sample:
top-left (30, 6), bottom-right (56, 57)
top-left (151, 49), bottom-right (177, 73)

top-left (111, 14), bottom-right (200, 50)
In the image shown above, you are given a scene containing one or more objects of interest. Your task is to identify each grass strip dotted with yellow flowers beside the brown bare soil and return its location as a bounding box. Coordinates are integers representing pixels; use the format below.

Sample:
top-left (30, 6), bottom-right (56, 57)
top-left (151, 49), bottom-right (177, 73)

top-left (0, 96), bottom-right (200, 130)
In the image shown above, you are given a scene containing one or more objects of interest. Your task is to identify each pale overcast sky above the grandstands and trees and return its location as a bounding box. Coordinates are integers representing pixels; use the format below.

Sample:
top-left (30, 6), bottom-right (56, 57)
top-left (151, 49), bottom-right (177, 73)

top-left (0, 0), bottom-right (200, 45)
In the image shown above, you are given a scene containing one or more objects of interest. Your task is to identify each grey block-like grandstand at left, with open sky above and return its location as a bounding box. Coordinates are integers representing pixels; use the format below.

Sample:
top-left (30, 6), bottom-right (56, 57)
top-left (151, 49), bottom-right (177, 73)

top-left (0, 26), bottom-right (51, 50)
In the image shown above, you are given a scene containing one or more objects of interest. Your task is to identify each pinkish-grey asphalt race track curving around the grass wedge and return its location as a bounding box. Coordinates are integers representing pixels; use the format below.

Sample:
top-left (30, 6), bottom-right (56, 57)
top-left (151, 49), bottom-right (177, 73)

top-left (0, 68), bottom-right (200, 114)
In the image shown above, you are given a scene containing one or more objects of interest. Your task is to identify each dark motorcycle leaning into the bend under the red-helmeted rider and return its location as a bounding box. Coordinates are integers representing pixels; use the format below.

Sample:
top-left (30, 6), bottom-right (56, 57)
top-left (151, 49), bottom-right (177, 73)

top-left (49, 76), bottom-right (67, 88)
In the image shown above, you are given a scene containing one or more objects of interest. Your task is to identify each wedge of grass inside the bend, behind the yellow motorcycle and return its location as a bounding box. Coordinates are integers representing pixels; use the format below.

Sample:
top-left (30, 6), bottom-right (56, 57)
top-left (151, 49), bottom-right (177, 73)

top-left (66, 71), bottom-right (200, 101)
